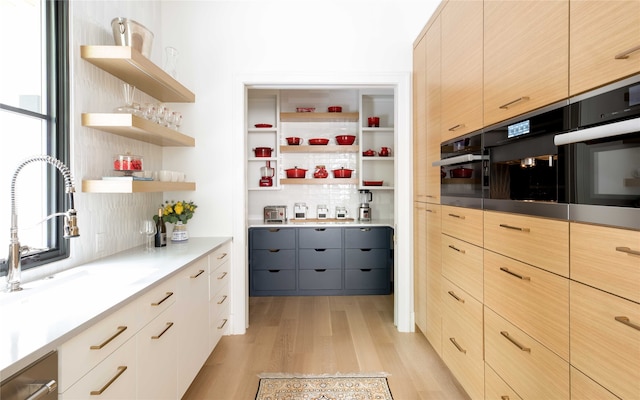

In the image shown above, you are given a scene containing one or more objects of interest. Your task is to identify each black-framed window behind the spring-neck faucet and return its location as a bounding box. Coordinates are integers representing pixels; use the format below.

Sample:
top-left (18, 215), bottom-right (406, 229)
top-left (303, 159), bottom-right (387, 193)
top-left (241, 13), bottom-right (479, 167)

top-left (0, 0), bottom-right (69, 275)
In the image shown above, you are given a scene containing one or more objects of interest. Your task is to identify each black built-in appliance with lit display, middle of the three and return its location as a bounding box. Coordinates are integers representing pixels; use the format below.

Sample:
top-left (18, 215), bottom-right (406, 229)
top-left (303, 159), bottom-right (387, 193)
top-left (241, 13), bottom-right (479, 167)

top-left (484, 101), bottom-right (575, 219)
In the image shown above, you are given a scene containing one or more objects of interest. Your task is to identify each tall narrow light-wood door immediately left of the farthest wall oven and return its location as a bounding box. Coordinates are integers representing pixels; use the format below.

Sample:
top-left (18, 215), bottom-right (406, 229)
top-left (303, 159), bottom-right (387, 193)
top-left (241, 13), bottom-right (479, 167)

top-left (426, 18), bottom-right (442, 203)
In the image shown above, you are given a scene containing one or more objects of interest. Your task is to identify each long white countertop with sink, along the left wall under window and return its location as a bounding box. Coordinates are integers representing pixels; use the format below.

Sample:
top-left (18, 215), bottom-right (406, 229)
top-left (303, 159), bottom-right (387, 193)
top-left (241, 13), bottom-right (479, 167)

top-left (0, 237), bottom-right (231, 381)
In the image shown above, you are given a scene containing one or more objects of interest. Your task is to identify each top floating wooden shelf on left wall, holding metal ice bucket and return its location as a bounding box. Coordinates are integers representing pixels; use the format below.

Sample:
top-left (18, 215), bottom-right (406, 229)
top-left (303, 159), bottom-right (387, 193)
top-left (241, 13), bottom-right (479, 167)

top-left (80, 46), bottom-right (196, 103)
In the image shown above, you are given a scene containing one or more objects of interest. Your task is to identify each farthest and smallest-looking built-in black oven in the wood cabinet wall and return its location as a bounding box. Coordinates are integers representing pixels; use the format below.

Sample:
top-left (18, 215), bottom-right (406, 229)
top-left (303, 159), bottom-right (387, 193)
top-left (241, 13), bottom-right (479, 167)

top-left (432, 131), bottom-right (489, 208)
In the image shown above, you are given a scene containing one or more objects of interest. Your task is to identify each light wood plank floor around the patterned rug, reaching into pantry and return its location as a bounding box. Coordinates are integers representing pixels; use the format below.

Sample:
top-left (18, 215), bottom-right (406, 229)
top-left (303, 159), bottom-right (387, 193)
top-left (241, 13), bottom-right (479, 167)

top-left (183, 296), bottom-right (468, 400)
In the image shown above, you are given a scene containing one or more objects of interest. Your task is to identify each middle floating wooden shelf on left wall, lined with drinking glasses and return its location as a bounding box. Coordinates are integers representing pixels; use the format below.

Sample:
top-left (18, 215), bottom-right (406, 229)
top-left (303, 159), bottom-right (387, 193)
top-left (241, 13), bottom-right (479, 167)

top-left (82, 113), bottom-right (196, 147)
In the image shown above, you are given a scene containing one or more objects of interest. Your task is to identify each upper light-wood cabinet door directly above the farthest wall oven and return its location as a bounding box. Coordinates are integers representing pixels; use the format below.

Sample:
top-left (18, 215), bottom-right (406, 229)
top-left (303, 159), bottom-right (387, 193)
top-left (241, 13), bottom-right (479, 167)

top-left (440, 0), bottom-right (483, 141)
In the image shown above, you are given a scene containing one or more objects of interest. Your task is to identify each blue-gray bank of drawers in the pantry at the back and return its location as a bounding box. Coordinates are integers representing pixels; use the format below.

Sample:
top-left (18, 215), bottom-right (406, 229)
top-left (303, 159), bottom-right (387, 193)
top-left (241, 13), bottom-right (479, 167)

top-left (249, 226), bottom-right (393, 296)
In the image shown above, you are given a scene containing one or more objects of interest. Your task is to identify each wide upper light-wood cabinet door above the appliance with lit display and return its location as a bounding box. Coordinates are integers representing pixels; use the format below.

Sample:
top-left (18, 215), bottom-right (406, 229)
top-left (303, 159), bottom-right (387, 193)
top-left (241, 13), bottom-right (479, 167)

top-left (483, 0), bottom-right (569, 126)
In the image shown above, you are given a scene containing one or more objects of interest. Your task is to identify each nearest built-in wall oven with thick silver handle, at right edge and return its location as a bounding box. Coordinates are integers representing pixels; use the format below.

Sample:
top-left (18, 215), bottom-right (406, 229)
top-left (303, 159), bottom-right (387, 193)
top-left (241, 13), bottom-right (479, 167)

top-left (554, 75), bottom-right (640, 229)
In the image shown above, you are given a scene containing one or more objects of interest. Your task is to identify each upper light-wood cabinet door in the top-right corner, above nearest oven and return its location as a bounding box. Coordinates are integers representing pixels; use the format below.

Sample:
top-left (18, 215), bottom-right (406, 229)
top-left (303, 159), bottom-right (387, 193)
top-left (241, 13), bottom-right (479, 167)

top-left (569, 0), bottom-right (640, 96)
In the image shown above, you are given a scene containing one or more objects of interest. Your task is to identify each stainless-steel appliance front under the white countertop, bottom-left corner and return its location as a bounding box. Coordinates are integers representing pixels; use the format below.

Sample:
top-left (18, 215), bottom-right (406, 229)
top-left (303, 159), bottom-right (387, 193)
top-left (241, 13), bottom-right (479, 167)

top-left (0, 351), bottom-right (58, 400)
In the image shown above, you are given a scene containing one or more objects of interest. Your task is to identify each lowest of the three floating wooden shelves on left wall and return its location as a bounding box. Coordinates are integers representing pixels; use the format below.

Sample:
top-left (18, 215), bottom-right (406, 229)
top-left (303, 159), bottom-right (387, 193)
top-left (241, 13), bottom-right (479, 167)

top-left (82, 179), bottom-right (196, 193)
